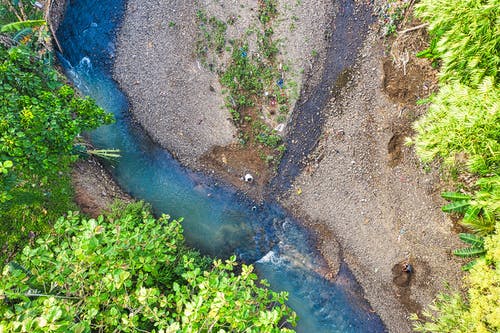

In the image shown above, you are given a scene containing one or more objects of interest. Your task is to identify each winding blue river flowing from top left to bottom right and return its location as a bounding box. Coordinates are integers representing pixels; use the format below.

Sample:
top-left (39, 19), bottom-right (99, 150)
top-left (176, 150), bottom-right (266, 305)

top-left (58, 0), bottom-right (384, 332)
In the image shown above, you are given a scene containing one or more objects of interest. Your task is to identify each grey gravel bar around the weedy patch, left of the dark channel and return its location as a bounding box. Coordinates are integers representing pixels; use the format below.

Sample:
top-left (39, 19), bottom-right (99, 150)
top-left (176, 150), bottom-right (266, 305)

top-left (114, 0), bottom-right (332, 199)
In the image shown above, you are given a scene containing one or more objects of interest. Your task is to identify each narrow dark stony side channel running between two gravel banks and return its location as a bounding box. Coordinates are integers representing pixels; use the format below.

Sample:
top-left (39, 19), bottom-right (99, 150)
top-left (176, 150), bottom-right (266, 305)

top-left (269, 0), bottom-right (374, 197)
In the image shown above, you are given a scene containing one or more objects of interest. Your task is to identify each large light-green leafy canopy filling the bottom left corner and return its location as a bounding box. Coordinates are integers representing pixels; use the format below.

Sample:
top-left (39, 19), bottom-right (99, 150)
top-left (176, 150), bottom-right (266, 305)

top-left (0, 203), bottom-right (295, 332)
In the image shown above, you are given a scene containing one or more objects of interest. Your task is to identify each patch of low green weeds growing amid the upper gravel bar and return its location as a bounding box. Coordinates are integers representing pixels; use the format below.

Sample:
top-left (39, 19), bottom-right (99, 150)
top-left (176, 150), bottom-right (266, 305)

top-left (196, 0), bottom-right (294, 166)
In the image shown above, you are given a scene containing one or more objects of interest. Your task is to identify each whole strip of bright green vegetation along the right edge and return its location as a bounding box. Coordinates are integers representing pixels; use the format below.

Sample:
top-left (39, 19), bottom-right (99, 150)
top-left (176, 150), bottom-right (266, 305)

top-left (414, 0), bottom-right (500, 332)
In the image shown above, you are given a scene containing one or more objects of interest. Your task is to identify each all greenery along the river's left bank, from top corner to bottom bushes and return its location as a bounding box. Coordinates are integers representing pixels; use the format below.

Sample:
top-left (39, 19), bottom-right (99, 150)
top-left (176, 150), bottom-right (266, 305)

top-left (0, 1), bottom-right (295, 332)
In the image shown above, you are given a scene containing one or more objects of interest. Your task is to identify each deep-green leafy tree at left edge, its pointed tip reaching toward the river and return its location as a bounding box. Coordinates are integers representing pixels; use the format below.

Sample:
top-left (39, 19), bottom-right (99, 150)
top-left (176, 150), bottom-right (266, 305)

top-left (0, 47), bottom-right (111, 176)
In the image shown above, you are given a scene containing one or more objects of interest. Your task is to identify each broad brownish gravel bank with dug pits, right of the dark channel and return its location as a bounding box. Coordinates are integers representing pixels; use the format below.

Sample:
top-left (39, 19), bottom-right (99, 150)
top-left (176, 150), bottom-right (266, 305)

top-left (284, 27), bottom-right (461, 332)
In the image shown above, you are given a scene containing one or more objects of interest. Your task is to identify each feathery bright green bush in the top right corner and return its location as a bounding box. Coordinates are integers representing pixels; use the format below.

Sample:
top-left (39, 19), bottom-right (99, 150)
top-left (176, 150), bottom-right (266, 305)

top-left (416, 0), bottom-right (500, 86)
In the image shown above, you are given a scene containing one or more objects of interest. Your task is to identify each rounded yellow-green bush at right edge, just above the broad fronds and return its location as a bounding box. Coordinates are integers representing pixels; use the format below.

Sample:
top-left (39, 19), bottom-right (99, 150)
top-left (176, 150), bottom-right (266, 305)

top-left (414, 80), bottom-right (500, 175)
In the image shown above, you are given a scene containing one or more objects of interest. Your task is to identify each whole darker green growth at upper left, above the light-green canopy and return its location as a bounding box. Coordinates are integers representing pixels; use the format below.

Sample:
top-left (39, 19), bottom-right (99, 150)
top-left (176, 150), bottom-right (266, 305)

top-left (0, 2), bottom-right (111, 261)
